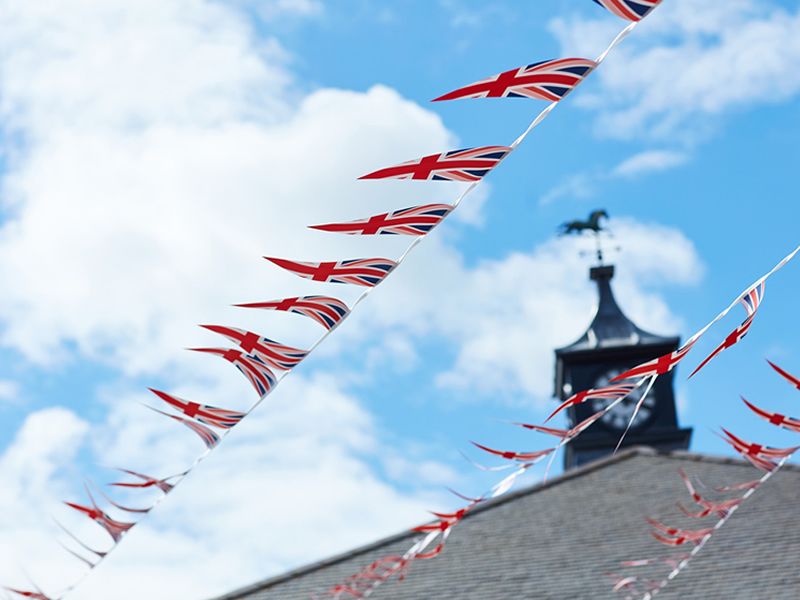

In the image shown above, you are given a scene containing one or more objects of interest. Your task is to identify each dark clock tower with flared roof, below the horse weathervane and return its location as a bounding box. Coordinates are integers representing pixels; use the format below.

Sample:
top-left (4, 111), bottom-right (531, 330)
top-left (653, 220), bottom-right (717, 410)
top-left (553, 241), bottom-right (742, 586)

top-left (555, 266), bottom-right (692, 469)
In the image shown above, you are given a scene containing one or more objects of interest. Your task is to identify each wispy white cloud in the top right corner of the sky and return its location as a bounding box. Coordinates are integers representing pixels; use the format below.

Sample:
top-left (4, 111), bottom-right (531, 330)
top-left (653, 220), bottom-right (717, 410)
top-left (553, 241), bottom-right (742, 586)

top-left (551, 0), bottom-right (800, 141)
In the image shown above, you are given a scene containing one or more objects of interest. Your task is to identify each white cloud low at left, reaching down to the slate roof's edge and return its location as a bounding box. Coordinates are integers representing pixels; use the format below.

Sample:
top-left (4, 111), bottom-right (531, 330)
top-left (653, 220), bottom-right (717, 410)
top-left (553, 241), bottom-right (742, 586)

top-left (0, 377), bottom-right (450, 600)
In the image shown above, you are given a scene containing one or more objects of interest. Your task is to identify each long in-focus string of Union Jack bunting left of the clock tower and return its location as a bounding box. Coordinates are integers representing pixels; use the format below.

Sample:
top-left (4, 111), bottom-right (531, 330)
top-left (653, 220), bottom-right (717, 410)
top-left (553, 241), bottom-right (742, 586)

top-left (7, 1), bottom-right (632, 600)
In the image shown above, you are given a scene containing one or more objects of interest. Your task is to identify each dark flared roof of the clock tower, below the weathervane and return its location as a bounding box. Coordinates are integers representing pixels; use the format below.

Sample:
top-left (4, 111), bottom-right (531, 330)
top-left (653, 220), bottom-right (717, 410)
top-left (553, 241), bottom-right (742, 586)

top-left (556, 265), bottom-right (678, 355)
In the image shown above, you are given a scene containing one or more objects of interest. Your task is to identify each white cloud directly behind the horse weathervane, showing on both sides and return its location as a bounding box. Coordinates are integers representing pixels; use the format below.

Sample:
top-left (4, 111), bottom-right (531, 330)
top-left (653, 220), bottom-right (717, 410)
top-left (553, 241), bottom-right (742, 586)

top-left (439, 221), bottom-right (701, 400)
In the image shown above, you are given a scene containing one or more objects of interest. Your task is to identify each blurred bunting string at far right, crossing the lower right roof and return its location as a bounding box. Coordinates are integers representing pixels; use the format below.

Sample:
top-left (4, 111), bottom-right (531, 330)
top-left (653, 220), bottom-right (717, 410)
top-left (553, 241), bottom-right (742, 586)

top-left (607, 361), bottom-right (800, 600)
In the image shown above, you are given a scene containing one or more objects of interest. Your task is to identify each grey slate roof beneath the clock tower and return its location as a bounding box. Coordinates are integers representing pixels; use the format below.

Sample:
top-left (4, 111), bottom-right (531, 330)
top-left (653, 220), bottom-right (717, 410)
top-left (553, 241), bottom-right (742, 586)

top-left (216, 448), bottom-right (800, 600)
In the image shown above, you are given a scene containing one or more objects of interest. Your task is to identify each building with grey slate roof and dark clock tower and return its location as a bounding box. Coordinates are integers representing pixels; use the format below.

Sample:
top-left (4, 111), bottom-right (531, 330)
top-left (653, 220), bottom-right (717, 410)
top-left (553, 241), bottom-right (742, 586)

top-left (216, 266), bottom-right (800, 600)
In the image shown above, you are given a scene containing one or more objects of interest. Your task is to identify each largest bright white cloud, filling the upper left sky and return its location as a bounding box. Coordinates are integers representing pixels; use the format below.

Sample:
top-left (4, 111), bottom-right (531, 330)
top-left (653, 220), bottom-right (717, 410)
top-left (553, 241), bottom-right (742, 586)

top-left (0, 0), bottom-right (468, 373)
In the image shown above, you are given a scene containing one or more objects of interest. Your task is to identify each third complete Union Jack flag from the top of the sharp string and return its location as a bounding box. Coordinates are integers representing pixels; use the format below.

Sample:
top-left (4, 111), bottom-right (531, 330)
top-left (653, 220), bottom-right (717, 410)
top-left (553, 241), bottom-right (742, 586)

top-left (310, 204), bottom-right (453, 235)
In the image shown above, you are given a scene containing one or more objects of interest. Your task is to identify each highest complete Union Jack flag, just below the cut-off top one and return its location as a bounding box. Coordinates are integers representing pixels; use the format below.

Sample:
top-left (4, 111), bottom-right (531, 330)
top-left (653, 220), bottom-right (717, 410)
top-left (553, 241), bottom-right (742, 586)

top-left (434, 58), bottom-right (597, 102)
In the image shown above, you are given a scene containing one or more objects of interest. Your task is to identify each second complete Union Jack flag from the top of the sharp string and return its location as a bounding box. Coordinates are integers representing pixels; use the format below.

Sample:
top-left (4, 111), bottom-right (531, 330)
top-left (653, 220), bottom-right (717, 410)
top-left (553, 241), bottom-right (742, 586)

top-left (359, 146), bottom-right (512, 181)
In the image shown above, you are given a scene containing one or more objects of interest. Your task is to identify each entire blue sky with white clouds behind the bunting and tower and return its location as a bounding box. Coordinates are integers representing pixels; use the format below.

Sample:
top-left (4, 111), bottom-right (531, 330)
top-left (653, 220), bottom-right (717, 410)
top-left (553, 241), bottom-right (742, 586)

top-left (0, 0), bottom-right (800, 598)
